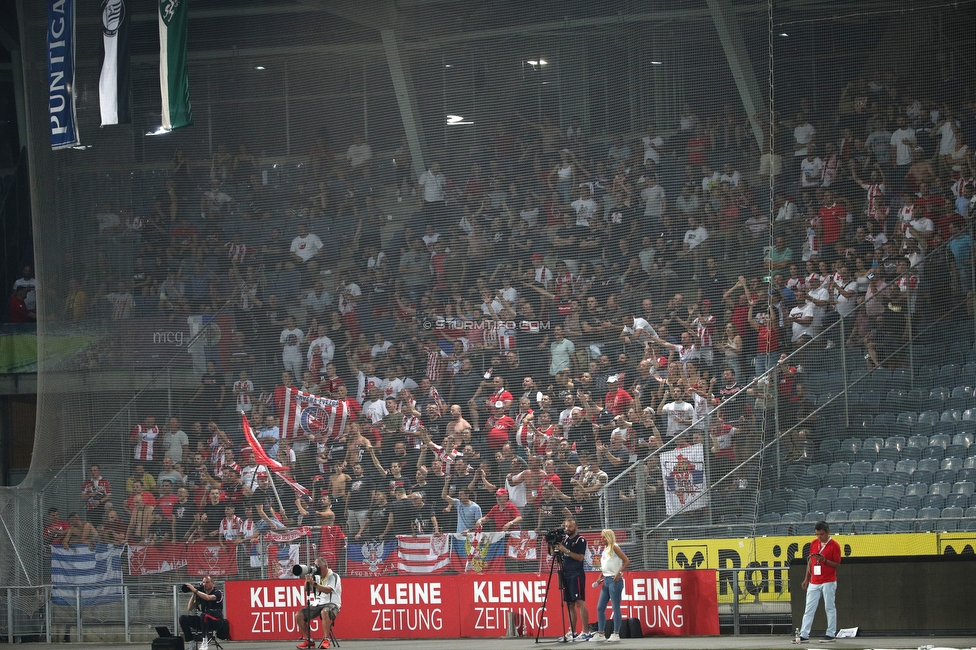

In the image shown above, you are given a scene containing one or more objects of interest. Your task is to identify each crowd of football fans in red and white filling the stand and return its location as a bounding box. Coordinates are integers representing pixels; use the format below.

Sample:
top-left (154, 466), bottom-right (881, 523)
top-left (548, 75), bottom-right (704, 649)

top-left (43, 69), bottom-right (976, 544)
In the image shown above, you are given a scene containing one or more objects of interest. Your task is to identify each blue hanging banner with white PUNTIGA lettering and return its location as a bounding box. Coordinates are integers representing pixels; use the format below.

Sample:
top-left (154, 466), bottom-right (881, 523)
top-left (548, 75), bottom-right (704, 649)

top-left (47, 0), bottom-right (81, 149)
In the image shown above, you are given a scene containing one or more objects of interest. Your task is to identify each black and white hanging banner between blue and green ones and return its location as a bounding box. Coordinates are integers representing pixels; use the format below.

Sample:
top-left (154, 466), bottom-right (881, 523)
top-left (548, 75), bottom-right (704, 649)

top-left (98, 0), bottom-right (132, 126)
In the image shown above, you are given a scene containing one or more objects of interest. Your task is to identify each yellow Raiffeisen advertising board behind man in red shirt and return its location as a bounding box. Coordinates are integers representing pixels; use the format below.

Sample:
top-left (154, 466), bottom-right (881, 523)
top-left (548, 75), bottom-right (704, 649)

top-left (668, 533), bottom-right (936, 603)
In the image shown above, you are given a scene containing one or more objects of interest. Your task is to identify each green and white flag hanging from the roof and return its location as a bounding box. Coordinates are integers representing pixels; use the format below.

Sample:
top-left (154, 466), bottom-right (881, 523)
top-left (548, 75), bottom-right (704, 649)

top-left (159, 0), bottom-right (193, 131)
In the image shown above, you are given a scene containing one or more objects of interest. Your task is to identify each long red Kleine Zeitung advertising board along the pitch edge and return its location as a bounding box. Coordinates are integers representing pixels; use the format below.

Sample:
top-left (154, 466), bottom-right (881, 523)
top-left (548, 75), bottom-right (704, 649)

top-left (225, 570), bottom-right (719, 641)
